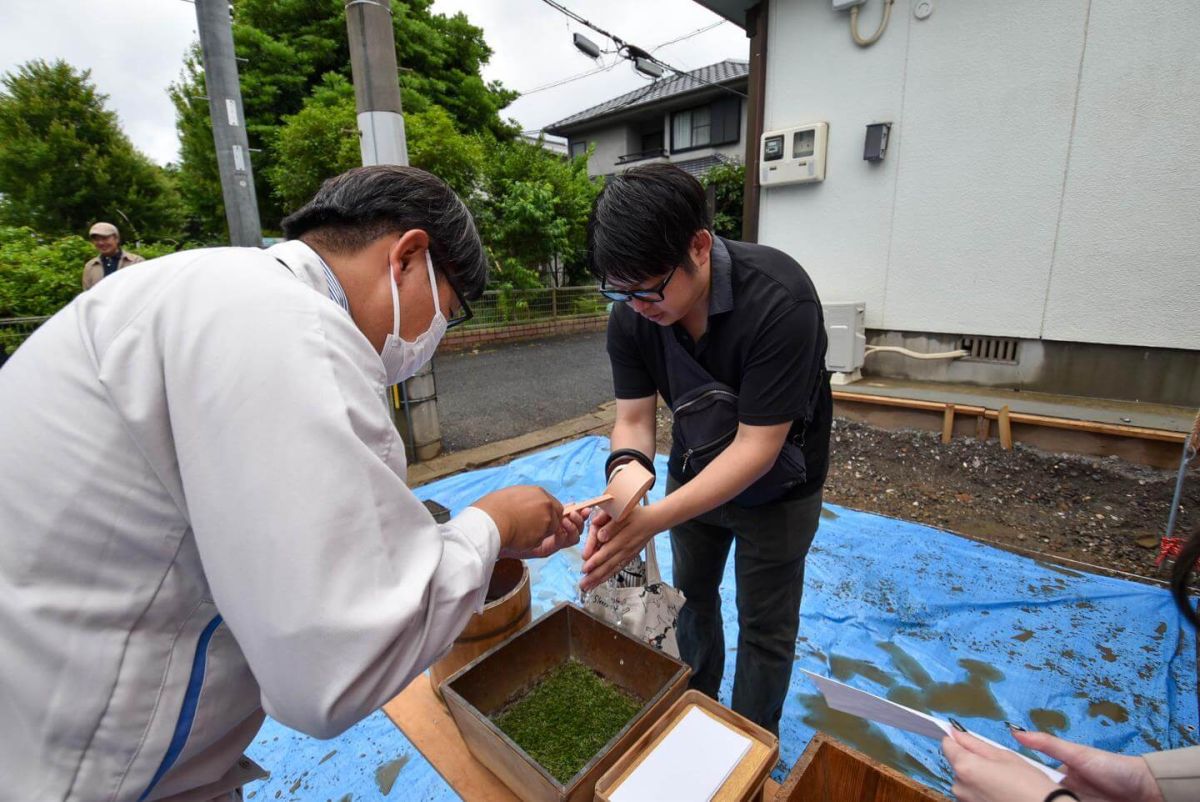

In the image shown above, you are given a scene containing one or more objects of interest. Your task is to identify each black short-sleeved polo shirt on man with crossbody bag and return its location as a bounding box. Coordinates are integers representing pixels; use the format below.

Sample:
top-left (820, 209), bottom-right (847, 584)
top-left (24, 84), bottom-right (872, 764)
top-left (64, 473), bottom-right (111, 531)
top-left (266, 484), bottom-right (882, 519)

top-left (608, 237), bottom-right (833, 497)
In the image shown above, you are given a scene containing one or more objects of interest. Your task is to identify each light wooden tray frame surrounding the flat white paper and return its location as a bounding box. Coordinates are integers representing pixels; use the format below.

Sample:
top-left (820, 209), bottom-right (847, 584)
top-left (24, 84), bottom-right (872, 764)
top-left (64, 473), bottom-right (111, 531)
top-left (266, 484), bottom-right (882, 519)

top-left (595, 690), bottom-right (779, 802)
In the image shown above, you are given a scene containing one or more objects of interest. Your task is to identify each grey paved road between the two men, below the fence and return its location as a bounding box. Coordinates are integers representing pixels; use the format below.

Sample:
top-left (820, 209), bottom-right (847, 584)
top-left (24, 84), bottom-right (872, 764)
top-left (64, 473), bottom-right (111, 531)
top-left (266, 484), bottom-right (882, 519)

top-left (433, 331), bottom-right (612, 451)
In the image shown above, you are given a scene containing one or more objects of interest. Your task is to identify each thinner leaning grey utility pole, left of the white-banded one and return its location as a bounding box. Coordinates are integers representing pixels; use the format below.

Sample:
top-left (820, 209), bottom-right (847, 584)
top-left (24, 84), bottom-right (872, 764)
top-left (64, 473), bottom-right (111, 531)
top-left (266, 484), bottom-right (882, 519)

top-left (196, 0), bottom-right (263, 247)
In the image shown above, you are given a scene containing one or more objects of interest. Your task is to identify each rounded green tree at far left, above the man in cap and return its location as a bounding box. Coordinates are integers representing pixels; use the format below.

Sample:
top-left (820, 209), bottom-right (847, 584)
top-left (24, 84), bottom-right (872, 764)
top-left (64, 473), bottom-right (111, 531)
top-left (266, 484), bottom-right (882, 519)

top-left (0, 60), bottom-right (180, 239)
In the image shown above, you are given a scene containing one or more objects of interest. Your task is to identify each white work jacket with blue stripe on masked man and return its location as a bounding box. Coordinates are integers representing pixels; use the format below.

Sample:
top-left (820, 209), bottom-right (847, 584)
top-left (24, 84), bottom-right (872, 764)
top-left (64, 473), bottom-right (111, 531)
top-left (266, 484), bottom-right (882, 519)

top-left (0, 241), bottom-right (499, 802)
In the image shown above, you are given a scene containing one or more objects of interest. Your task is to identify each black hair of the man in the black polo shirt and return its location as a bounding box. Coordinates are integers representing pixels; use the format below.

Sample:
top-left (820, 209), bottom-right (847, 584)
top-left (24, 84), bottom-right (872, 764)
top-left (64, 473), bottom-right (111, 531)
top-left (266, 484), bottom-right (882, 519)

top-left (588, 164), bottom-right (712, 287)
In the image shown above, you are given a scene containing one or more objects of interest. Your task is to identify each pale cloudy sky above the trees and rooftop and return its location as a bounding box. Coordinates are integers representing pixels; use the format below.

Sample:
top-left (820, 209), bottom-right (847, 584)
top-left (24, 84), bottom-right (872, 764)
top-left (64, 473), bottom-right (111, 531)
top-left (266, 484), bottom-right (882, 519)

top-left (0, 0), bottom-right (748, 163)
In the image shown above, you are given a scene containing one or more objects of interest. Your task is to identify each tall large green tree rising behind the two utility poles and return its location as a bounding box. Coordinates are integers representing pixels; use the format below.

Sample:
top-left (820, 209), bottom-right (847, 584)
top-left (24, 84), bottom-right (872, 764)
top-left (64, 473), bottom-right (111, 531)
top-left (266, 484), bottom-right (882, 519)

top-left (170, 0), bottom-right (516, 238)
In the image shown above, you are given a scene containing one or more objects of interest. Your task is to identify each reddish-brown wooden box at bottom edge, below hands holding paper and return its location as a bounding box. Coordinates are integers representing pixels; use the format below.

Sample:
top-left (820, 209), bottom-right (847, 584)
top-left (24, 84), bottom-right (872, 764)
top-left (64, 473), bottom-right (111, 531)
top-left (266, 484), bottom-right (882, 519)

top-left (775, 732), bottom-right (950, 802)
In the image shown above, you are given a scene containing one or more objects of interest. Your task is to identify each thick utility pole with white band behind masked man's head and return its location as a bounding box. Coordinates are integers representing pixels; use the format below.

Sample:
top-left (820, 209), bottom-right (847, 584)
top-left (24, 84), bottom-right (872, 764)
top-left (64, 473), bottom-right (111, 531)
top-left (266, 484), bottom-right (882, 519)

top-left (346, 0), bottom-right (442, 462)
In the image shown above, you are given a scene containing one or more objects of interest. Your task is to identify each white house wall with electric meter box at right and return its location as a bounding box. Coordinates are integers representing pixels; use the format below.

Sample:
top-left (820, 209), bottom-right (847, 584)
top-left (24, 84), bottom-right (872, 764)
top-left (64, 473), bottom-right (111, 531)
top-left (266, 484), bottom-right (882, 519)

top-left (760, 0), bottom-right (1200, 348)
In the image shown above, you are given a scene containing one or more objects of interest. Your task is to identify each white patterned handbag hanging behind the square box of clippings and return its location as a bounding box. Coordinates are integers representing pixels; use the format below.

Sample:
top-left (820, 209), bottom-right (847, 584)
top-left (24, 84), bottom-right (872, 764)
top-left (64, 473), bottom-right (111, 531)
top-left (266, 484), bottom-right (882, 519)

top-left (583, 538), bottom-right (684, 659)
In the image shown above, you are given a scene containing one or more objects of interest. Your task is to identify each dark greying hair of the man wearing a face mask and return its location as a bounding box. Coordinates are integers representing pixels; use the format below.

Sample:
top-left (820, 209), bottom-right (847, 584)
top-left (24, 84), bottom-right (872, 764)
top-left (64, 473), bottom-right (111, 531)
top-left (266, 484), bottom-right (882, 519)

top-left (282, 164), bottom-right (487, 299)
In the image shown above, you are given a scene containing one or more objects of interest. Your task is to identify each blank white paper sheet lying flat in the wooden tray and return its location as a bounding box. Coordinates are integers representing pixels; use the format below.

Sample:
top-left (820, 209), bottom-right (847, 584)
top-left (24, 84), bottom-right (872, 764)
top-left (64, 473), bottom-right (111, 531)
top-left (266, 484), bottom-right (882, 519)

top-left (610, 706), bottom-right (751, 802)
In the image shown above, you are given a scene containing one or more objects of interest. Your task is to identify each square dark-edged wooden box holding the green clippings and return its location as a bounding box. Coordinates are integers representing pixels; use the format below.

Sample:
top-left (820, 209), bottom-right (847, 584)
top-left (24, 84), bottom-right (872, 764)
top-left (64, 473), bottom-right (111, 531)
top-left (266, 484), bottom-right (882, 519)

top-left (442, 603), bottom-right (691, 802)
